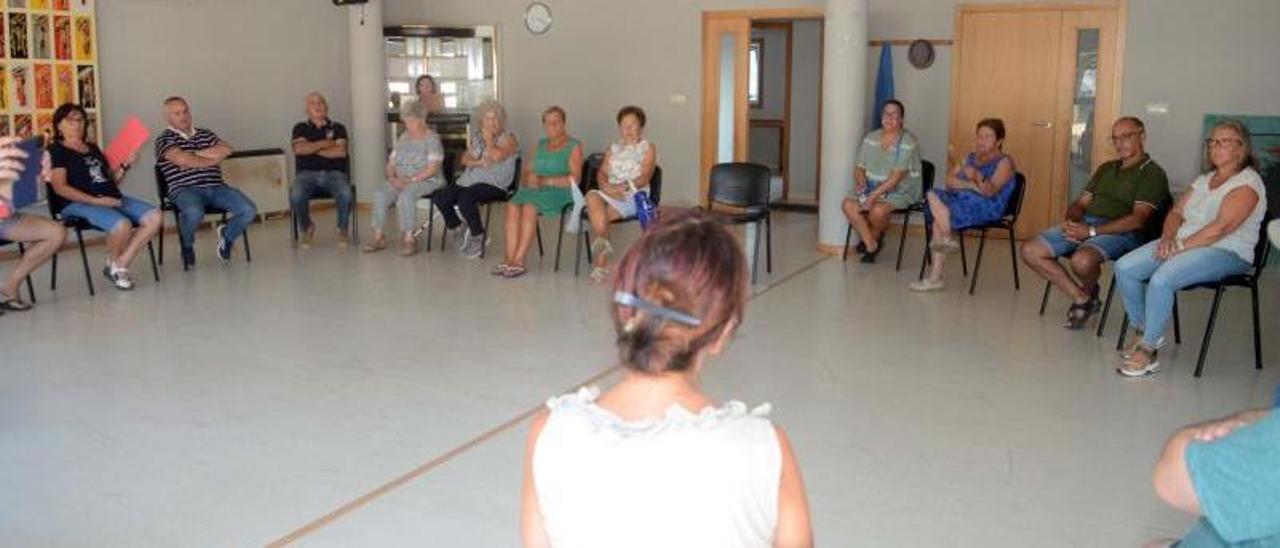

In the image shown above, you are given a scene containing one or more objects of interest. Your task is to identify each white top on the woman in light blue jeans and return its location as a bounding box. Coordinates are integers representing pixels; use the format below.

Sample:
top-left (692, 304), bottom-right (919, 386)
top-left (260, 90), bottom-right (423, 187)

top-left (1178, 168), bottom-right (1267, 264)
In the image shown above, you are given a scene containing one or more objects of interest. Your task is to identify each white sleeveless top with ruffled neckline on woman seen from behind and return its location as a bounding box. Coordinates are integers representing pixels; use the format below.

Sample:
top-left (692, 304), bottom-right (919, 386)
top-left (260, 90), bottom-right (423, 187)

top-left (532, 387), bottom-right (782, 548)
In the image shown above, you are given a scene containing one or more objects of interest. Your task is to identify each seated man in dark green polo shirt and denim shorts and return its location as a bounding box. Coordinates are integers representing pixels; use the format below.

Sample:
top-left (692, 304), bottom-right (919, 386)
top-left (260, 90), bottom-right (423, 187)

top-left (1023, 117), bottom-right (1172, 329)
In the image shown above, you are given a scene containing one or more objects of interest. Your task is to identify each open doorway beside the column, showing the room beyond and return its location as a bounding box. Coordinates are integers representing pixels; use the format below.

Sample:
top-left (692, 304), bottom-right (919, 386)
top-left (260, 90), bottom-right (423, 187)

top-left (746, 19), bottom-right (823, 211)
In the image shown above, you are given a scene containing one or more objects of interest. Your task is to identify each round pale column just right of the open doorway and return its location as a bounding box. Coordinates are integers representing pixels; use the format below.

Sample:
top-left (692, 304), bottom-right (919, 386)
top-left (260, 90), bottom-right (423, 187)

top-left (818, 0), bottom-right (867, 252)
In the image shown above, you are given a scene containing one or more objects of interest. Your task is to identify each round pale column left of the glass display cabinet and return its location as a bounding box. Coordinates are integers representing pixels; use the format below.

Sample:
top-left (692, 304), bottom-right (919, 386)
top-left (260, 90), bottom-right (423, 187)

top-left (347, 0), bottom-right (388, 207)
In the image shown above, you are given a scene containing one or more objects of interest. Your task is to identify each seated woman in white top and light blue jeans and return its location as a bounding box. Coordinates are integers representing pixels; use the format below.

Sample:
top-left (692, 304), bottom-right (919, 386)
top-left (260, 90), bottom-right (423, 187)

top-left (1115, 120), bottom-right (1267, 376)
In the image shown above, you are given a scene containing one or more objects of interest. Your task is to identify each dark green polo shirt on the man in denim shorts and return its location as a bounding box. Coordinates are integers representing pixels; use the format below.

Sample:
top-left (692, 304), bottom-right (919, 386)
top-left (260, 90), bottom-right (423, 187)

top-left (1084, 155), bottom-right (1172, 222)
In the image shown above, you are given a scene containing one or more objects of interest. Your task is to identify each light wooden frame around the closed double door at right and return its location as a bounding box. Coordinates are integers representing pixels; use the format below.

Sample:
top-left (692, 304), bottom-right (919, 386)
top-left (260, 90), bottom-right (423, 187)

top-left (946, 0), bottom-right (1129, 233)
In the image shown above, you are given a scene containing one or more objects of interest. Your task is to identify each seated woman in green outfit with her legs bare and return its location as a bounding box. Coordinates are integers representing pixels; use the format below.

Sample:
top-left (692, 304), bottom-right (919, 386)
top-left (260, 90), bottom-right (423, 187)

top-left (490, 106), bottom-right (582, 278)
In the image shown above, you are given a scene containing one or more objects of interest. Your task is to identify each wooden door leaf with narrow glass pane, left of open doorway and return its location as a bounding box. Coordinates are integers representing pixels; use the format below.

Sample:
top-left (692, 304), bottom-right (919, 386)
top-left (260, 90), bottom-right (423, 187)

top-left (698, 13), bottom-right (751, 205)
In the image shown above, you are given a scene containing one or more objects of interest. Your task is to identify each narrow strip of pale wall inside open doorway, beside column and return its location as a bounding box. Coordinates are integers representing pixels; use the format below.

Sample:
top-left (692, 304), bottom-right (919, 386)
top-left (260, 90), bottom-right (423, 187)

top-left (787, 20), bottom-right (822, 200)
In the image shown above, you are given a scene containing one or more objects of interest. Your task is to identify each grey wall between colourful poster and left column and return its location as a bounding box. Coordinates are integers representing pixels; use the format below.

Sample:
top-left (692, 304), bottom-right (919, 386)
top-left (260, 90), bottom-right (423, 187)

top-left (97, 0), bottom-right (351, 200)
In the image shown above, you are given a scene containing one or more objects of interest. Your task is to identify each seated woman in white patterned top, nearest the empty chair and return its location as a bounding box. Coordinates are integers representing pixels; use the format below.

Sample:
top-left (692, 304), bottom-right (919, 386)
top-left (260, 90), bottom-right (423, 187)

top-left (586, 106), bottom-right (658, 283)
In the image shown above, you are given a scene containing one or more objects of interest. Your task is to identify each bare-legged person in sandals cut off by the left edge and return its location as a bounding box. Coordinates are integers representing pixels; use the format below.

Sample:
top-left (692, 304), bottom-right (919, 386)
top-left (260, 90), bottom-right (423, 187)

top-left (0, 137), bottom-right (67, 309)
